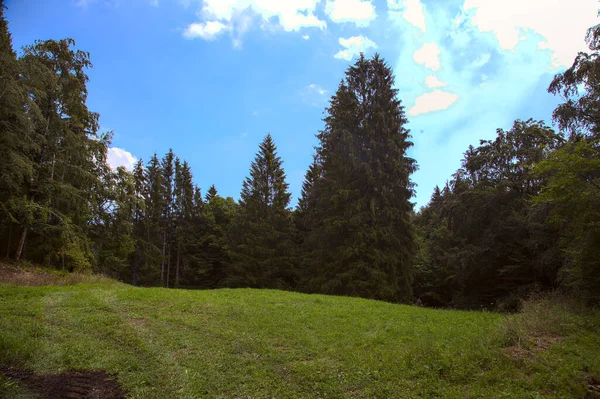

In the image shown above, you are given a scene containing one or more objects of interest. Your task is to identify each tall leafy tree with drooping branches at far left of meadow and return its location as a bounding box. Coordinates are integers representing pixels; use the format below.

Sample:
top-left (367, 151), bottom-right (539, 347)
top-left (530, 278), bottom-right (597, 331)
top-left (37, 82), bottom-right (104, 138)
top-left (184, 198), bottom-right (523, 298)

top-left (9, 39), bottom-right (110, 269)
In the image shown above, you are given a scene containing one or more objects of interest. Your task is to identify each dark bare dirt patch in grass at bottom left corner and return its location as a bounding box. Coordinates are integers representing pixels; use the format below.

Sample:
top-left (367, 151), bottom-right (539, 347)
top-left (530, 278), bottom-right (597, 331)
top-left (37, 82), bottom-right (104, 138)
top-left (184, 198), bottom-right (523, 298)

top-left (0, 367), bottom-right (126, 399)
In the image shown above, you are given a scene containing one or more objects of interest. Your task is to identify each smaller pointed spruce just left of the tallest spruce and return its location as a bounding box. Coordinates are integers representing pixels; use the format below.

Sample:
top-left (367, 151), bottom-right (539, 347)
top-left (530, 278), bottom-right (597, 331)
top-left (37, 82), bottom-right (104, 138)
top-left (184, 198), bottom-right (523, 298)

top-left (227, 134), bottom-right (297, 289)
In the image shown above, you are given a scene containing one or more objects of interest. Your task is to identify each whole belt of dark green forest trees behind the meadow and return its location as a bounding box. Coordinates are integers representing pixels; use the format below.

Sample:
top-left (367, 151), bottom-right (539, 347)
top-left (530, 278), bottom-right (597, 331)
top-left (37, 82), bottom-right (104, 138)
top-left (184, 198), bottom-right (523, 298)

top-left (0, 2), bottom-right (600, 311)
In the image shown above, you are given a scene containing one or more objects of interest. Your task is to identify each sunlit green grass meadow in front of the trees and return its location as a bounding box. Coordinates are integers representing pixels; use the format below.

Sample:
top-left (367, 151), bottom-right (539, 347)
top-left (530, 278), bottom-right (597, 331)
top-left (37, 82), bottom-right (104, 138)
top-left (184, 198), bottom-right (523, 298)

top-left (0, 268), bottom-right (600, 399)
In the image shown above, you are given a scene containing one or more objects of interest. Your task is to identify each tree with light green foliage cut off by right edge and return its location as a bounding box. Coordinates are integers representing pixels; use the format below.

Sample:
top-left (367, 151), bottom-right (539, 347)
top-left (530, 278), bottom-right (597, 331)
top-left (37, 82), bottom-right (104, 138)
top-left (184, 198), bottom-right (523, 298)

top-left (535, 25), bottom-right (600, 303)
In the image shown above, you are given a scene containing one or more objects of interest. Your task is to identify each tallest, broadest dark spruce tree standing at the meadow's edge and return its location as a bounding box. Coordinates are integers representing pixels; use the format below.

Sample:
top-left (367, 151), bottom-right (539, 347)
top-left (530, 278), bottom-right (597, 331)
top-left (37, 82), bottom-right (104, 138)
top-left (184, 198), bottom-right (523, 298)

top-left (303, 54), bottom-right (416, 301)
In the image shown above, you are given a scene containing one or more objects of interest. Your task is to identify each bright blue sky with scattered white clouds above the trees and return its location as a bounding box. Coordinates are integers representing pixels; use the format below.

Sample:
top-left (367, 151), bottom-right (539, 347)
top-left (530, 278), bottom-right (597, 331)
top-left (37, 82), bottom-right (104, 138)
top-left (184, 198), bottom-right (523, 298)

top-left (5, 0), bottom-right (600, 208)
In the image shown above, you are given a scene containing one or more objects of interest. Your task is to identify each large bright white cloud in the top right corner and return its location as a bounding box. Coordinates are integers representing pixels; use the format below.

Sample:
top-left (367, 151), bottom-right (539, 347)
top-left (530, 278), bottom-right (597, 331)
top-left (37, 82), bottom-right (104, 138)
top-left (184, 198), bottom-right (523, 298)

top-left (463, 0), bottom-right (598, 67)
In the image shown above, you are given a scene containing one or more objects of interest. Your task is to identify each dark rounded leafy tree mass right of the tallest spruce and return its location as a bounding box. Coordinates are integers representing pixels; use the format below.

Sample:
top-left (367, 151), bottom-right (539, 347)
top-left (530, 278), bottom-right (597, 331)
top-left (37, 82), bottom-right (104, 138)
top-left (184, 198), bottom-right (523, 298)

top-left (415, 120), bottom-right (562, 308)
